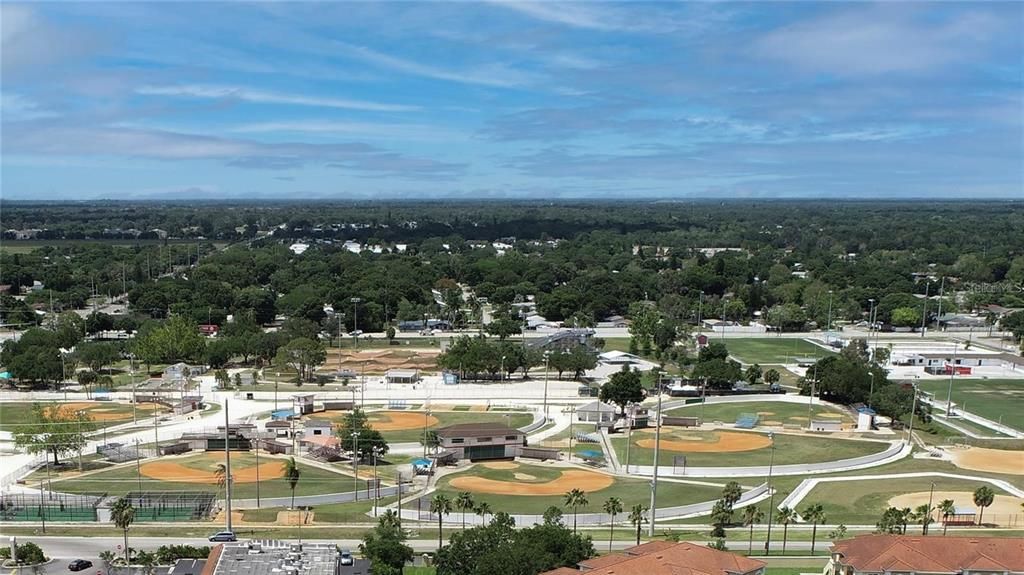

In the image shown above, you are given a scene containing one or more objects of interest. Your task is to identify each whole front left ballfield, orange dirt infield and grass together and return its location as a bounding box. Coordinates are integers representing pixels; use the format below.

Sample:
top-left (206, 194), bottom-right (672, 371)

top-left (52, 452), bottom-right (352, 499)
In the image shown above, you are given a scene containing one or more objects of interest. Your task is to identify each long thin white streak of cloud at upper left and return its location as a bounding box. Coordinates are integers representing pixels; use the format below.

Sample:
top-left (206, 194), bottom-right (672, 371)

top-left (135, 84), bottom-right (420, 112)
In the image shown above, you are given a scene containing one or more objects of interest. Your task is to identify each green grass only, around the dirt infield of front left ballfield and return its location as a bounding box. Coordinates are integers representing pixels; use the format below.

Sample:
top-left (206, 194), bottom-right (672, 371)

top-left (53, 453), bottom-right (361, 499)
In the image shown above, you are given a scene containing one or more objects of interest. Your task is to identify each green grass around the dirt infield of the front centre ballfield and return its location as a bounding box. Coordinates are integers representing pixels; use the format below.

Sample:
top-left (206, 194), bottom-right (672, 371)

top-left (428, 465), bottom-right (722, 515)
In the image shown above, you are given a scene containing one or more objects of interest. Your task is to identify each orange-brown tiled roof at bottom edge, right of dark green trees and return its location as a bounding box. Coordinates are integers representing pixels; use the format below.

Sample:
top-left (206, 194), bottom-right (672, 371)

top-left (542, 541), bottom-right (765, 575)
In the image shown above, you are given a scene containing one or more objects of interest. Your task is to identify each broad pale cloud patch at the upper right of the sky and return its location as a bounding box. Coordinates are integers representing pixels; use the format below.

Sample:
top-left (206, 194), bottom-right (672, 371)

top-left (754, 6), bottom-right (1001, 76)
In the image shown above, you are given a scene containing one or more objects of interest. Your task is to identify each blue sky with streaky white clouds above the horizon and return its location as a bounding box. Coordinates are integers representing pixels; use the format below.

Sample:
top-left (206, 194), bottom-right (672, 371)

top-left (0, 0), bottom-right (1024, 200)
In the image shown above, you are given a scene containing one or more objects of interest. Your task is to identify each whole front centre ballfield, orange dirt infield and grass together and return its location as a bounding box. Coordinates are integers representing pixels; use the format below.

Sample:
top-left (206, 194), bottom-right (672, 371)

top-left (423, 463), bottom-right (722, 515)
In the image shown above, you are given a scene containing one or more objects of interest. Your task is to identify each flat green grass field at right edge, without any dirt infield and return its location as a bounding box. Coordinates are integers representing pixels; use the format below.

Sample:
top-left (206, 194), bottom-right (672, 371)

top-left (918, 378), bottom-right (1024, 431)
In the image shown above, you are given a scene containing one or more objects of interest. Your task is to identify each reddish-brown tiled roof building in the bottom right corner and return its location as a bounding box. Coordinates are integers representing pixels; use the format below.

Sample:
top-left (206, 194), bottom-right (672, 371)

top-left (824, 535), bottom-right (1024, 575)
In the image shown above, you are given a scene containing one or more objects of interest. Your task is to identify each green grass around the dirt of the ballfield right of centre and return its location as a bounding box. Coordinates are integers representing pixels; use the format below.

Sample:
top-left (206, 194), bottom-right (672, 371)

top-left (611, 428), bottom-right (888, 467)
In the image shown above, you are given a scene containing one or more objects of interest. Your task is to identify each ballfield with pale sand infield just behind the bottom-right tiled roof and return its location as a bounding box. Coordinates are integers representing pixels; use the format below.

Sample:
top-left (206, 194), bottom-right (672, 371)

top-left (800, 477), bottom-right (1024, 533)
